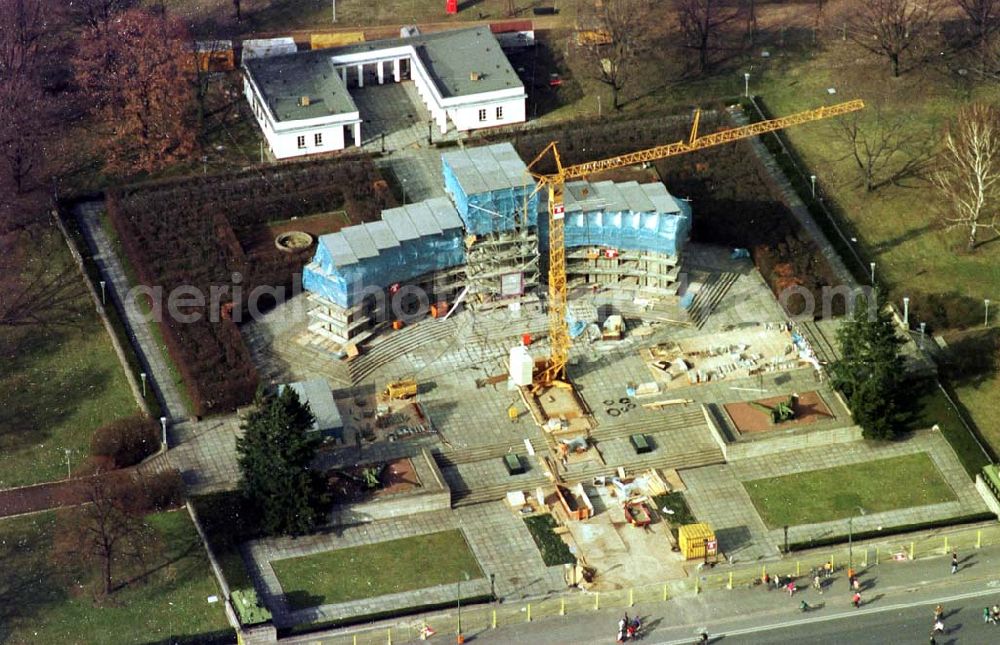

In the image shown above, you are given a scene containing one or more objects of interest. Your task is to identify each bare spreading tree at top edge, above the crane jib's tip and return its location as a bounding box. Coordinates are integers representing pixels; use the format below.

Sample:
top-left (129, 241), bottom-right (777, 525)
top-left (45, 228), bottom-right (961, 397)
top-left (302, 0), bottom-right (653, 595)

top-left (849, 0), bottom-right (942, 77)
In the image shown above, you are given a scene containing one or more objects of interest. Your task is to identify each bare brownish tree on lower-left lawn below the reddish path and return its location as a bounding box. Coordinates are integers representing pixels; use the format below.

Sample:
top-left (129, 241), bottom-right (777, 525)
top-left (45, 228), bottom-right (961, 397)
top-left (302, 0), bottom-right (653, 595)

top-left (56, 474), bottom-right (155, 595)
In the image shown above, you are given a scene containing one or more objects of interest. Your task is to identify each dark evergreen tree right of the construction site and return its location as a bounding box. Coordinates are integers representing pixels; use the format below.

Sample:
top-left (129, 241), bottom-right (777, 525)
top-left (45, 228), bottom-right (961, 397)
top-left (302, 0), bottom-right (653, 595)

top-left (832, 289), bottom-right (904, 439)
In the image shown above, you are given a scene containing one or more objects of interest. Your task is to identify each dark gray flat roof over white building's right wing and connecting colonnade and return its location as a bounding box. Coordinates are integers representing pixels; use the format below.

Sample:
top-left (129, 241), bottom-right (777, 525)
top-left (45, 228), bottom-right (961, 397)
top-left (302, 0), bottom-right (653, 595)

top-left (326, 27), bottom-right (524, 98)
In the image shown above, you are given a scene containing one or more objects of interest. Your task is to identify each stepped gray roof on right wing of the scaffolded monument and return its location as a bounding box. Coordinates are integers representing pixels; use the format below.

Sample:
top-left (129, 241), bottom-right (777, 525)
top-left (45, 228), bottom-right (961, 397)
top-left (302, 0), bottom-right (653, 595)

top-left (563, 181), bottom-right (681, 213)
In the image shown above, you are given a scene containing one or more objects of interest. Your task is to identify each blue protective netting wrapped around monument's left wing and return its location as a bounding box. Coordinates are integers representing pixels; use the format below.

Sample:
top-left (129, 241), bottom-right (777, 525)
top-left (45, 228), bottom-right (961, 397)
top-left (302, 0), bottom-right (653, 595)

top-left (302, 229), bottom-right (465, 307)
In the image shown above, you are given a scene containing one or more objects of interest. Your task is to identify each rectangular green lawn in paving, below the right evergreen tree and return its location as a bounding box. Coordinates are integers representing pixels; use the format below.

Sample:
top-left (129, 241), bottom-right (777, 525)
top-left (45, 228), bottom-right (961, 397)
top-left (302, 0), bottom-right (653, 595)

top-left (743, 453), bottom-right (956, 528)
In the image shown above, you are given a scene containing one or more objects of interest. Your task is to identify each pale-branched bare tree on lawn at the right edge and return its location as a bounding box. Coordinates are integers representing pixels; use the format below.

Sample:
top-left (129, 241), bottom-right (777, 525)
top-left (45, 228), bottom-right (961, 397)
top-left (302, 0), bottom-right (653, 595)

top-left (931, 103), bottom-right (1000, 250)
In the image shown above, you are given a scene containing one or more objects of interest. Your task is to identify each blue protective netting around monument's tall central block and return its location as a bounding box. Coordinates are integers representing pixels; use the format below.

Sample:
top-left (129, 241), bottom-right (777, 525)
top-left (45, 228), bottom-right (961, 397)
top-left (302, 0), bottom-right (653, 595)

top-left (441, 158), bottom-right (539, 235)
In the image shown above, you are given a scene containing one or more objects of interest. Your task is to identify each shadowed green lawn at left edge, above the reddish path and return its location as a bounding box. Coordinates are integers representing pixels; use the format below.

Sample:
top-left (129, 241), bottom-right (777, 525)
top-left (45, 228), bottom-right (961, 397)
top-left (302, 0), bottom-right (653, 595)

top-left (0, 228), bottom-right (137, 488)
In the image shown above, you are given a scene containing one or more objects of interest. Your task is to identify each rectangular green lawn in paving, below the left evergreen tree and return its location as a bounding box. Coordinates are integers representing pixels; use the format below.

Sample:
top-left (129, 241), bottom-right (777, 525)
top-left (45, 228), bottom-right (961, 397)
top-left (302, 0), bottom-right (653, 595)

top-left (271, 529), bottom-right (483, 609)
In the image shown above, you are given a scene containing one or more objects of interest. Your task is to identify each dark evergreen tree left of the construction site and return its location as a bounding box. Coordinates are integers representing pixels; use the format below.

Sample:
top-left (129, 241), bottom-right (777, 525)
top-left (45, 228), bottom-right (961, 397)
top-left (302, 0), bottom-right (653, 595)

top-left (236, 387), bottom-right (326, 535)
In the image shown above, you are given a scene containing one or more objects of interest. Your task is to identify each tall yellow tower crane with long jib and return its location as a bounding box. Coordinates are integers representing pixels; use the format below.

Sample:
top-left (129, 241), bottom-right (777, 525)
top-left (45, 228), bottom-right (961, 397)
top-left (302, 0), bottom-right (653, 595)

top-left (528, 100), bottom-right (865, 387)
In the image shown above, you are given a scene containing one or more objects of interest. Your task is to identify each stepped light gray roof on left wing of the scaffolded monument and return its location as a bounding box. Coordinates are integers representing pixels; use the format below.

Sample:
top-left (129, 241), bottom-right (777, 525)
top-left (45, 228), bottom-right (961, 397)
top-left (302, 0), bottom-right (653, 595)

top-left (319, 197), bottom-right (462, 267)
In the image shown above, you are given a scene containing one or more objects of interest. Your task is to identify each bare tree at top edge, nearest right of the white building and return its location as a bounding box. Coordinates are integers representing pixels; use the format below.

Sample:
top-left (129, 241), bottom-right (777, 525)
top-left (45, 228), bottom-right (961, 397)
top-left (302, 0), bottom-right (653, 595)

top-left (583, 0), bottom-right (651, 110)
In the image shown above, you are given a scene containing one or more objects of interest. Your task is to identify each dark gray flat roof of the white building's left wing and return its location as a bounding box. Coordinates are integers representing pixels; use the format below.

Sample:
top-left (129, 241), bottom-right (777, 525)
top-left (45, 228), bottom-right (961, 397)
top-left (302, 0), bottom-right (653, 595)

top-left (243, 49), bottom-right (358, 122)
